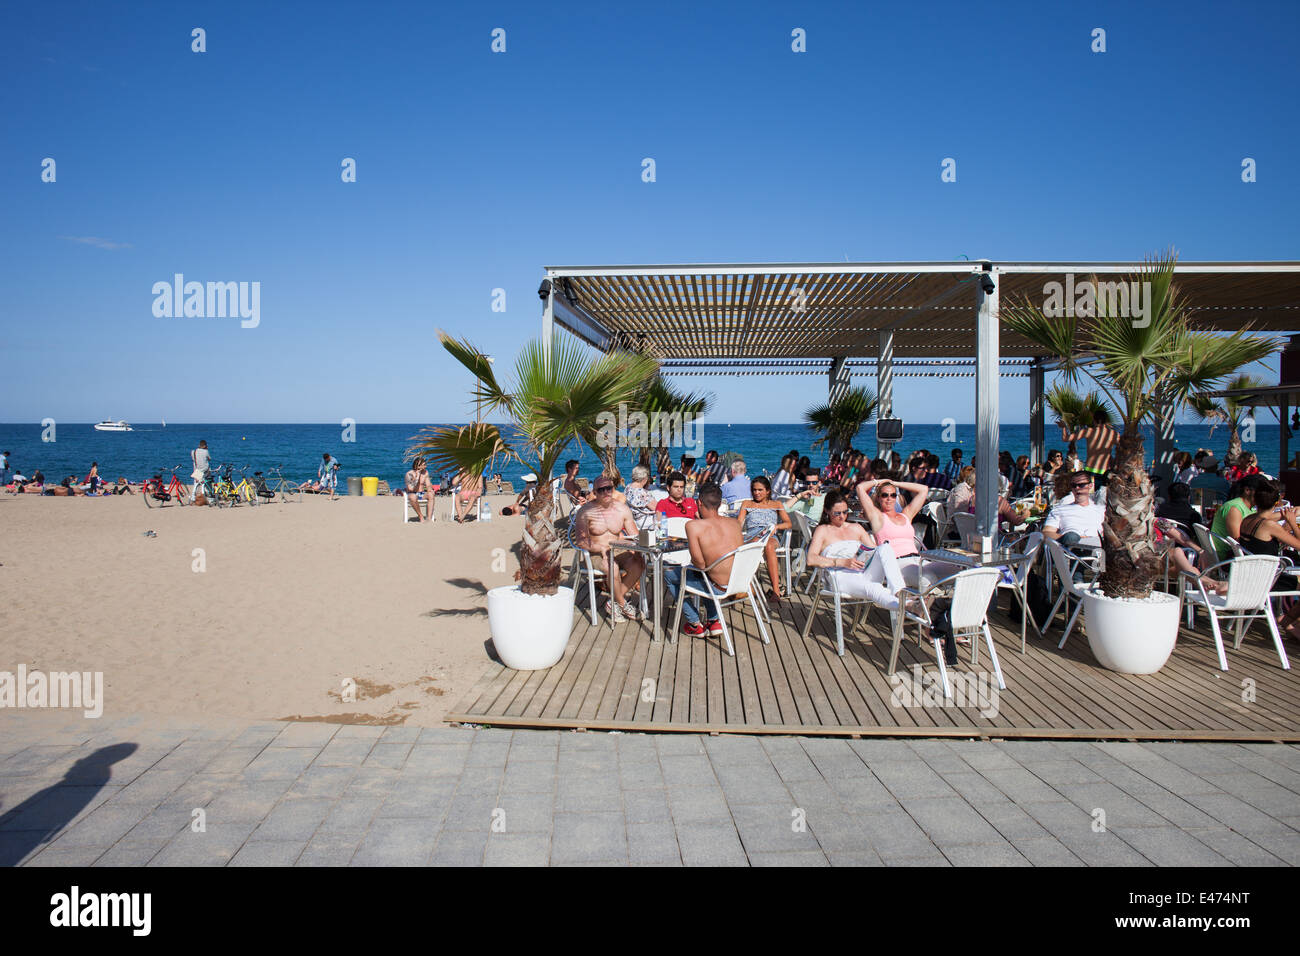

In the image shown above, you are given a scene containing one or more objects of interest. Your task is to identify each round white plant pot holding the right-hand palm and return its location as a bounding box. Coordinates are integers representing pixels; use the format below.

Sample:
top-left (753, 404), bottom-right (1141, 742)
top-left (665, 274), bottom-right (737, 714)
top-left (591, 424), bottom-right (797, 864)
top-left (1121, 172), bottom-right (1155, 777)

top-left (1083, 591), bottom-right (1178, 674)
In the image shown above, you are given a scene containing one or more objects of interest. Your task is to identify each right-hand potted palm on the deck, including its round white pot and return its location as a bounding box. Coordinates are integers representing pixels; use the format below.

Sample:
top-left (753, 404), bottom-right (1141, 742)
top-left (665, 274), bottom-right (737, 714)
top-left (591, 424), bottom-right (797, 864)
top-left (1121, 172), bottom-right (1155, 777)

top-left (1001, 252), bottom-right (1282, 674)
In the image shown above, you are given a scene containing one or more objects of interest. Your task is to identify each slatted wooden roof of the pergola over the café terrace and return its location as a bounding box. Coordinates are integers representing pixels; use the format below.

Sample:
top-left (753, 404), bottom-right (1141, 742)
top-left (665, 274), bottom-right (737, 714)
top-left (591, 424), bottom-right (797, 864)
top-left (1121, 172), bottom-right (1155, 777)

top-left (547, 261), bottom-right (1300, 360)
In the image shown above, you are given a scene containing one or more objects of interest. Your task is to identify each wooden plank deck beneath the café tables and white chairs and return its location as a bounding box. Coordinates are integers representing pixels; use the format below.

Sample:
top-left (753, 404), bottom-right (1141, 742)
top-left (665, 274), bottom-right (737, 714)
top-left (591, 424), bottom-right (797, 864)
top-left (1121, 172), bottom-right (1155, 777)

top-left (446, 582), bottom-right (1300, 741)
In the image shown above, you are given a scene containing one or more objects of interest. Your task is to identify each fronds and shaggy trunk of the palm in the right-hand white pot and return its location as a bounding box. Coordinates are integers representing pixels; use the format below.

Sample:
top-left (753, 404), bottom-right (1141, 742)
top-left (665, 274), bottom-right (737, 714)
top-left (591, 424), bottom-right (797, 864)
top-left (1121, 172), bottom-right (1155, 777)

top-left (1001, 252), bottom-right (1282, 598)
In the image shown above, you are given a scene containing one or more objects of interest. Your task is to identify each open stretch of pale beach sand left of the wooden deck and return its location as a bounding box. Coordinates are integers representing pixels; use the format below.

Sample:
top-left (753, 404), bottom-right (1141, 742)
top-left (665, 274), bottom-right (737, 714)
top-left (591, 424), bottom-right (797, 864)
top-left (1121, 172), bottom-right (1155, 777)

top-left (0, 494), bottom-right (523, 727)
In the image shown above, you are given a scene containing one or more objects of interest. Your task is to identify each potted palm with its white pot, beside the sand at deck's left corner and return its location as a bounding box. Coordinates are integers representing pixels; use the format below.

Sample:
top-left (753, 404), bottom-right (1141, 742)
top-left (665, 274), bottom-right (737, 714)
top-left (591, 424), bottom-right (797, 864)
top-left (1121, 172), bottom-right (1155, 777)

top-left (407, 330), bottom-right (659, 670)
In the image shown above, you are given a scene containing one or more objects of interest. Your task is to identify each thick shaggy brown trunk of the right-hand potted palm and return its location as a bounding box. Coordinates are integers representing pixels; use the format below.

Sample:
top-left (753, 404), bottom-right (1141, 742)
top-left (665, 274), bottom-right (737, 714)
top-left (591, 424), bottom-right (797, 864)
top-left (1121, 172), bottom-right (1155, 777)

top-left (1099, 421), bottom-right (1160, 598)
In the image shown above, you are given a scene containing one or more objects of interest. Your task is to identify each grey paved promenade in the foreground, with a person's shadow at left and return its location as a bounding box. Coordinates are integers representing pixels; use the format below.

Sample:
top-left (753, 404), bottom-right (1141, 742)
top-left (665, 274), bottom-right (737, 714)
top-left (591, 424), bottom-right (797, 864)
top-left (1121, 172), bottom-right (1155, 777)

top-left (0, 710), bottom-right (1300, 866)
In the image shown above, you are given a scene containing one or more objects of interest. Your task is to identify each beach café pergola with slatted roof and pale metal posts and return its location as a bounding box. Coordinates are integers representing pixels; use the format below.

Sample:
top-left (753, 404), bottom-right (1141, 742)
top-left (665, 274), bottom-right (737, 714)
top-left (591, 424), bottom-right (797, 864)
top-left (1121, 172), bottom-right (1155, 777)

top-left (540, 260), bottom-right (1300, 540)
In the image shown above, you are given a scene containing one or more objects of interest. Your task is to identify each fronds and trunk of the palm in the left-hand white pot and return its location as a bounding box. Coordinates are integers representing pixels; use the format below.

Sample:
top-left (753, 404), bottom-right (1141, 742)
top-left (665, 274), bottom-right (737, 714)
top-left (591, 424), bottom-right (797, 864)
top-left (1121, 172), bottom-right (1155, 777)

top-left (407, 329), bottom-right (659, 594)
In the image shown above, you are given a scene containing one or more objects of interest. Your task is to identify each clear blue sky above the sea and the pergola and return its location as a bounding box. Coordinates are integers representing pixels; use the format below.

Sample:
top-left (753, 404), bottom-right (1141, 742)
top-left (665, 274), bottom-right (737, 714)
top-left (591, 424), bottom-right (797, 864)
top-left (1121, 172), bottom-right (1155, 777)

top-left (0, 1), bottom-right (1300, 423)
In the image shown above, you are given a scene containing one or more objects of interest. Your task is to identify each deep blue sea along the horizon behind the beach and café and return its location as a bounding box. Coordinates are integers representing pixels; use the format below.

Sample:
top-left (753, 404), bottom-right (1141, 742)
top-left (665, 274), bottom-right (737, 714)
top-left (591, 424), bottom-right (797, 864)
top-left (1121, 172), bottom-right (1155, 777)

top-left (0, 420), bottom-right (1279, 488)
